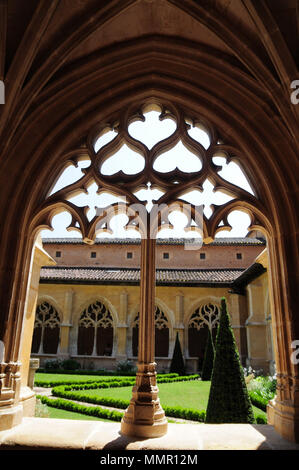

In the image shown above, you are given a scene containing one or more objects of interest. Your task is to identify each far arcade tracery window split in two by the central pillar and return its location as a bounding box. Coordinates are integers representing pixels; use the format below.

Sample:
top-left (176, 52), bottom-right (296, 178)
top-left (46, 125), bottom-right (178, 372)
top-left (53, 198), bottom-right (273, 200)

top-left (132, 306), bottom-right (169, 357)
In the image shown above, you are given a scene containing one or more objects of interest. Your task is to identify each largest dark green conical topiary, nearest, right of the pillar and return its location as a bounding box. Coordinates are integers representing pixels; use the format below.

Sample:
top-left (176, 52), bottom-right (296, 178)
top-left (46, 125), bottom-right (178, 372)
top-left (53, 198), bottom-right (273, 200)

top-left (205, 298), bottom-right (255, 423)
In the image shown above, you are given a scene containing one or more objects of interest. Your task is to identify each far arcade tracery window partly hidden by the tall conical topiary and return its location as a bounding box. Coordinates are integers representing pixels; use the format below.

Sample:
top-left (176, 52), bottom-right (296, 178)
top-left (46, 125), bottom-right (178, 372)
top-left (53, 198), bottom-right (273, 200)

top-left (188, 303), bottom-right (220, 369)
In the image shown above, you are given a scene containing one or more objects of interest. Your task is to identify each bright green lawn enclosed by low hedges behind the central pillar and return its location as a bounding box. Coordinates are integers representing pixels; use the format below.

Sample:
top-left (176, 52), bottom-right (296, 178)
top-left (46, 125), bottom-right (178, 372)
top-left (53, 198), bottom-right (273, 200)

top-left (63, 380), bottom-right (266, 416)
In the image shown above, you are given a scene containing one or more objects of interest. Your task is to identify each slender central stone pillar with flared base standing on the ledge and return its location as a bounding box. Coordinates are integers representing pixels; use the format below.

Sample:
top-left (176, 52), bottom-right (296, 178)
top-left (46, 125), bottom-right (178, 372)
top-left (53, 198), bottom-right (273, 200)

top-left (121, 215), bottom-right (167, 438)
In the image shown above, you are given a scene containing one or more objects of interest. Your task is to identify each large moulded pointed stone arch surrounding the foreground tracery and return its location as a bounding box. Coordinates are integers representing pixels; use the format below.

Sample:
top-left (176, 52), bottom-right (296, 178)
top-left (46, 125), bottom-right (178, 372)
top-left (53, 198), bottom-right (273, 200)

top-left (0, 19), bottom-right (299, 440)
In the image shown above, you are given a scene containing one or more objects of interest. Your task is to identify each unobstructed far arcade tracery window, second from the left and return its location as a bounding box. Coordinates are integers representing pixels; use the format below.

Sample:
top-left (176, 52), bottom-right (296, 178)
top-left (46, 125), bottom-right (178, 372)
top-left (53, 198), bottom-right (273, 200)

top-left (78, 301), bottom-right (113, 356)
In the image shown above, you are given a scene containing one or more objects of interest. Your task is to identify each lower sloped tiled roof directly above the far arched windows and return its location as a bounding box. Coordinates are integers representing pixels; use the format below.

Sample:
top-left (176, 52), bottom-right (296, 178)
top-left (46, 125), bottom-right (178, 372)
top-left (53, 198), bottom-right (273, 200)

top-left (40, 266), bottom-right (244, 285)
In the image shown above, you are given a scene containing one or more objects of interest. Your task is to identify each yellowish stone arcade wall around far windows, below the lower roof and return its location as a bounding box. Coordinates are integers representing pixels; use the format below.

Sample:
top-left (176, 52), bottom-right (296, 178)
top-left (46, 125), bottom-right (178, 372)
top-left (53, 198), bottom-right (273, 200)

top-left (33, 284), bottom-right (276, 372)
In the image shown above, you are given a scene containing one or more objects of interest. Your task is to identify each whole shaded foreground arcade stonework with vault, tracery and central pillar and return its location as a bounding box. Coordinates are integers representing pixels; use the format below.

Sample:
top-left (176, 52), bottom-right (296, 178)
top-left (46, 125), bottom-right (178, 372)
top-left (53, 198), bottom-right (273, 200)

top-left (0, 0), bottom-right (299, 442)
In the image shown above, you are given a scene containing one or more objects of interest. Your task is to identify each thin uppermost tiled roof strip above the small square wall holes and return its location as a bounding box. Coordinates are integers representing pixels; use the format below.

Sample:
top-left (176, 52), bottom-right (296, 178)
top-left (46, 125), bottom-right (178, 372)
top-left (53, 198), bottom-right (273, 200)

top-left (43, 237), bottom-right (265, 246)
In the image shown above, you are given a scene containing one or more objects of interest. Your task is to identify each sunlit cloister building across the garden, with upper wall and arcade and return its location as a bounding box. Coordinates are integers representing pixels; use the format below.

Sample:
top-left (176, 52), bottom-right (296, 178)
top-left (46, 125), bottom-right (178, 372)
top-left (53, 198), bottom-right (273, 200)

top-left (32, 237), bottom-right (273, 373)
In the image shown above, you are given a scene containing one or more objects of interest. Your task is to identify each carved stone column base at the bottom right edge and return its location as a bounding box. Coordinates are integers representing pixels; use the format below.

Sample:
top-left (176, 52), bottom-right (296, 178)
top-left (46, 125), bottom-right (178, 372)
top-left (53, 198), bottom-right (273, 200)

top-left (267, 400), bottom-right (299, 443)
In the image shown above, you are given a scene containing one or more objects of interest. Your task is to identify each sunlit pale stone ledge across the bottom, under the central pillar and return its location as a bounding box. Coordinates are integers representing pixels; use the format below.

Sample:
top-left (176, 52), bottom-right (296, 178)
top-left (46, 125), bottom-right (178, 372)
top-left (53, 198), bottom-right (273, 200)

top-left (0, 418), bottom-right (299, 451)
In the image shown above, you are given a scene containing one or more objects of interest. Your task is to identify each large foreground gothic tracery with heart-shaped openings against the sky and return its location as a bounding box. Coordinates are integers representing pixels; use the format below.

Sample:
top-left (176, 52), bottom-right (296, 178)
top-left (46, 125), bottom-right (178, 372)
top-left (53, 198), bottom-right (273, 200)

top-left (36, 100), bottom-right (264, 250)
